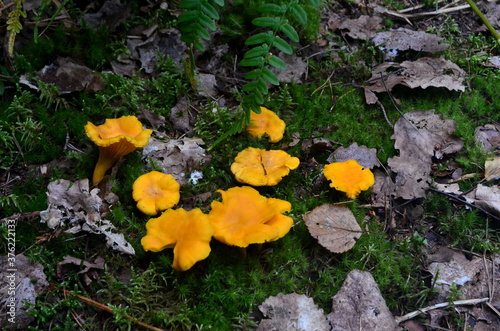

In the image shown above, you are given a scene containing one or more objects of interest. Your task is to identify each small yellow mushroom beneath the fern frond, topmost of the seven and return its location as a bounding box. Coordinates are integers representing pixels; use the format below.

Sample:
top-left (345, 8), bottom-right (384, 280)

top-left (246, 107), bottom-right (286, 143)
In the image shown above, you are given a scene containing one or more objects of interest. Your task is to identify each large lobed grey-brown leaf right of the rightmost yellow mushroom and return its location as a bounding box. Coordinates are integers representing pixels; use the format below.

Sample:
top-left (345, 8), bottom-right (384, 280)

top-left (387, 110), bottom-right (463, 200)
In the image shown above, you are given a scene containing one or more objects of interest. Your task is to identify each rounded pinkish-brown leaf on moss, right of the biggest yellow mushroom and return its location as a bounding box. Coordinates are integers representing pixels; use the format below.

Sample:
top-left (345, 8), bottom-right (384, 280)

top-left (304, 204), bottom-right (361, 253)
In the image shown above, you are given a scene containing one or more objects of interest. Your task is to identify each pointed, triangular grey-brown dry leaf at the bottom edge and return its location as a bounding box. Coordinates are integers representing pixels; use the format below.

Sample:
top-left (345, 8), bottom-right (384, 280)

top-left (327, 270), bottom-right (397, 331)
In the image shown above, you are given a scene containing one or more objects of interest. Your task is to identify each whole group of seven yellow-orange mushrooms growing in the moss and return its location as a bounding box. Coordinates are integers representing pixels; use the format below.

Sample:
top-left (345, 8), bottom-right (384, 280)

top-left (85, 107), bottom-right (374, 271)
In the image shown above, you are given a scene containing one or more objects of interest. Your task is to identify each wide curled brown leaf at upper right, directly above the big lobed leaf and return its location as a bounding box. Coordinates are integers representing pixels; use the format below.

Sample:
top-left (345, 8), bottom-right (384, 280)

top-left (365, 57), bottom-right (465, 104)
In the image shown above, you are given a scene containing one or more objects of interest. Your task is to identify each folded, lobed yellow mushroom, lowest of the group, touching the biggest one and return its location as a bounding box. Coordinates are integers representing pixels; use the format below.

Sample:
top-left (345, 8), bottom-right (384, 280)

top-left (141, 208), bottom-right (214, 271)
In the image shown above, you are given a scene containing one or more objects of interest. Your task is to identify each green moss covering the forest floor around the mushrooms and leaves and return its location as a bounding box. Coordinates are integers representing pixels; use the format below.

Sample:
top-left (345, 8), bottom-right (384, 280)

top-left (0, 1), bottom-right (500, 330)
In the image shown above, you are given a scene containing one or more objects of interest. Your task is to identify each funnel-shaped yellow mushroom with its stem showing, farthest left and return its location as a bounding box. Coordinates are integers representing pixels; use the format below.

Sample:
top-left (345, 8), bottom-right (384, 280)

top-left (85, 116), bottom-right (152, 184)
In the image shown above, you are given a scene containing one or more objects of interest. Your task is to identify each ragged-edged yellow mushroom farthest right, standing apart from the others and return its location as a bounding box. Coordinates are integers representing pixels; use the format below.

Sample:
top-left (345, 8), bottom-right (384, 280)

top-left (323, 160), bottom-right (375, 199)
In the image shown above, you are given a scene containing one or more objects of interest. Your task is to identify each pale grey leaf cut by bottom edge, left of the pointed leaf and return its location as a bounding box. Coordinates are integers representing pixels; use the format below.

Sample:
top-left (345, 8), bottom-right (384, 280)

top-left (257, 293), bottom-right (330, 331)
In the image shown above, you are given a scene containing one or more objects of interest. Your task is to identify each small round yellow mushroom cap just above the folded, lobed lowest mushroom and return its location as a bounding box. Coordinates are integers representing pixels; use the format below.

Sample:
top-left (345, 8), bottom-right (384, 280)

top-left (132, 171), bottom-right (181, 216)
